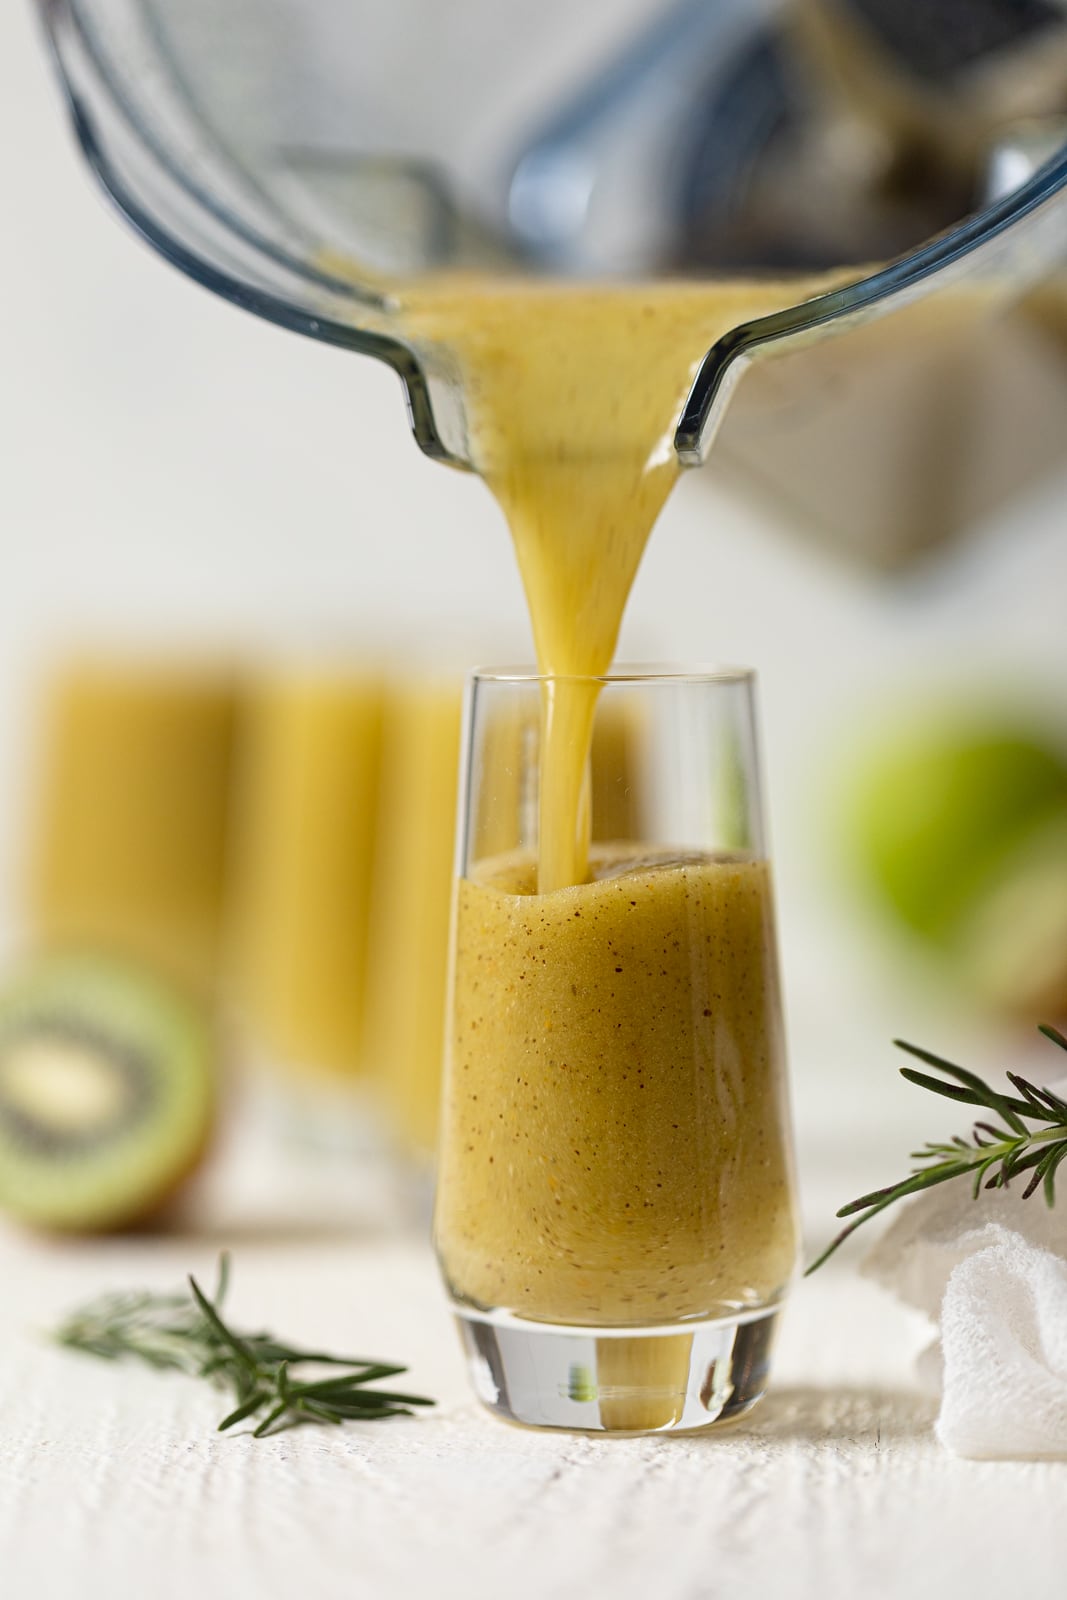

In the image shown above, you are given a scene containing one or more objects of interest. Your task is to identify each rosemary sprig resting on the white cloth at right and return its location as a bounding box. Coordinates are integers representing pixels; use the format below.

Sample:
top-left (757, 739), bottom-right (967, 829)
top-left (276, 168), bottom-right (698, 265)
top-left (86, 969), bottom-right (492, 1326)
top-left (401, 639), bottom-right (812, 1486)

top-left (805, 1024), bottom-right (1067, 1277)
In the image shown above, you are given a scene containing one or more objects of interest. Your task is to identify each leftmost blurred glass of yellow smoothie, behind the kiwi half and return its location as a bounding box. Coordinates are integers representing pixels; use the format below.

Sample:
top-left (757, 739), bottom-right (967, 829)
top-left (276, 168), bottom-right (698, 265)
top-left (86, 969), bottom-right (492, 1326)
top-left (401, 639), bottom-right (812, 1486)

top-left (26, 656), bottom-right (242, 992)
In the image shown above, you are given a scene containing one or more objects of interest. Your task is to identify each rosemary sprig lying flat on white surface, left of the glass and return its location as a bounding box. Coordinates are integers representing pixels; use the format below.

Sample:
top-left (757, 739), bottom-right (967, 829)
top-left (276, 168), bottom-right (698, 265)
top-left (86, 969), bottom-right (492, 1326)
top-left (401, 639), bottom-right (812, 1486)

top-left (54, 1254), bottom-right (434, 1438)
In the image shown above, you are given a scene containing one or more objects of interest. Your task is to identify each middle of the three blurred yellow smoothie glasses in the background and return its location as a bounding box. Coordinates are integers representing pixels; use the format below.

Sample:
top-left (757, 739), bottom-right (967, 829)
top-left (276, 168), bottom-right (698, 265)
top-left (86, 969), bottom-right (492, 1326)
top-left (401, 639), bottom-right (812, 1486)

top-left (232, 664), bottom-right (384, 1091)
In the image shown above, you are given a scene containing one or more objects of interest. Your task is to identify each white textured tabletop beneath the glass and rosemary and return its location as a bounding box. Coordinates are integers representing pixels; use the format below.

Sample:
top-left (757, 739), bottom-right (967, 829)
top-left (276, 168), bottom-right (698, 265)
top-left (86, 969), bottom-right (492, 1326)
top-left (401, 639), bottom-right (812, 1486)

top-left (0, 1209), bottom-right (1067, 1600)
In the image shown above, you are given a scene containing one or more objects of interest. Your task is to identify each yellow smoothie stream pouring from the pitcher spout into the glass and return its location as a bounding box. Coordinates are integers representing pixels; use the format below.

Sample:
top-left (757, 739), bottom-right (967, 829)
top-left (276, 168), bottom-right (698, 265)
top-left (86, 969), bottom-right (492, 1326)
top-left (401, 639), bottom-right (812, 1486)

top-left (402, 278), bottom-right (816, 893)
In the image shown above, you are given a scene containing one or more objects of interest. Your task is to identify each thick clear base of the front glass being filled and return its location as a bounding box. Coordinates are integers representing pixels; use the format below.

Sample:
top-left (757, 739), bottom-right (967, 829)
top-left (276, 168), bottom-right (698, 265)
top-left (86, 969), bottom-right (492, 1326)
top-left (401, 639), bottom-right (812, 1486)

top-left (454, 1306), bottom-right (781, 1434)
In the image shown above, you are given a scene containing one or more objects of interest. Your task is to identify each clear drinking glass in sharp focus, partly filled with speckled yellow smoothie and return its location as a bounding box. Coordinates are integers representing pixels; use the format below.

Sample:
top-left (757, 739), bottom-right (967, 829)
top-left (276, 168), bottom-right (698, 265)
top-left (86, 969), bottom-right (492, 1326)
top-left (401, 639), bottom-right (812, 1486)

top-left (435, 670), bottom-right (800, 1432)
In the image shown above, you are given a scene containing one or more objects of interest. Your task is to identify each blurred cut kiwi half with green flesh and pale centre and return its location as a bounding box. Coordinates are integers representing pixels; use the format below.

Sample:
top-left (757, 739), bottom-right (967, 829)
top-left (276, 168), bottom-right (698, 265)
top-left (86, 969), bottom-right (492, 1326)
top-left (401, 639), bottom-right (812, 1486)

top-left (0, 954), bottom-right (216, 1232)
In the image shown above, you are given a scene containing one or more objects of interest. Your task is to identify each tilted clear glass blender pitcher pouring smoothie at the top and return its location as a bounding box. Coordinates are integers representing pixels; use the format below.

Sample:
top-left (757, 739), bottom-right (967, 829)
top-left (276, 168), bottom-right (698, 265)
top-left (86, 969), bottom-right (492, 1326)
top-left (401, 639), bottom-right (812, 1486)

top-left (38, 0), bottom-right (1067, 565)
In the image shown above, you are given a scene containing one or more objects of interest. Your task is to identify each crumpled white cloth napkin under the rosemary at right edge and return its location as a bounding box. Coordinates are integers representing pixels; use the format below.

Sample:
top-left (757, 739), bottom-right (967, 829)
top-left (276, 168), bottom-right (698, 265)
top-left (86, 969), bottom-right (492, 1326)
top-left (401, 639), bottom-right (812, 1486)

top-left (862, 1083), bottom-right (1067, 1461)
